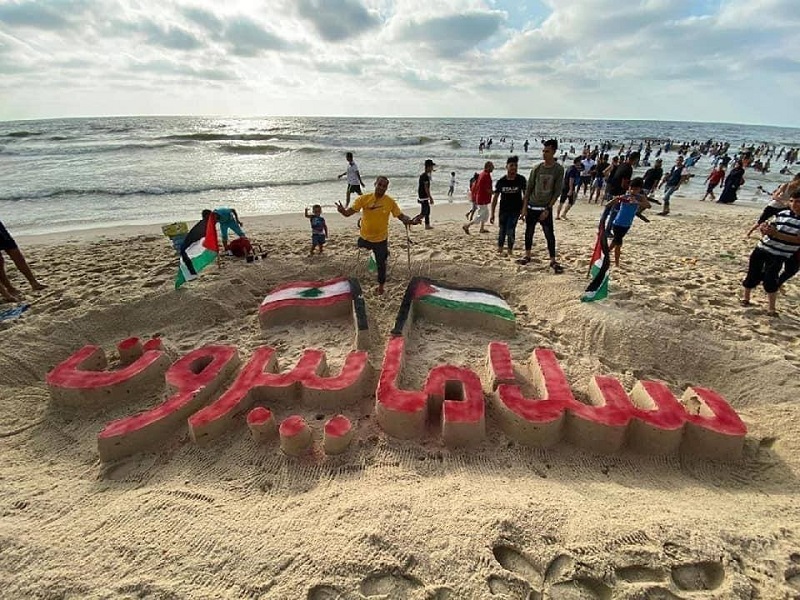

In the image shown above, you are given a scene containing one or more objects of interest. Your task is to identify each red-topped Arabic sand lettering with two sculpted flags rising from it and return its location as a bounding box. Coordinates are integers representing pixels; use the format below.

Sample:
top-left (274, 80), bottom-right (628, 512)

top-left (47, 278), bottom-right (747, 461)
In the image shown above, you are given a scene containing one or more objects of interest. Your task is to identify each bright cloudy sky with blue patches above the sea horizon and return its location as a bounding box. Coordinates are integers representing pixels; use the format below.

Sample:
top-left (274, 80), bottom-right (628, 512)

top-left (0, 0), bottom-right (800, 127)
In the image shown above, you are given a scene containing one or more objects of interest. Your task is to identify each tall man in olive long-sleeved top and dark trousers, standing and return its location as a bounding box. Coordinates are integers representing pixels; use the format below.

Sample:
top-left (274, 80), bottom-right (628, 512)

top-left (517, 140), bottom-right (564, 273)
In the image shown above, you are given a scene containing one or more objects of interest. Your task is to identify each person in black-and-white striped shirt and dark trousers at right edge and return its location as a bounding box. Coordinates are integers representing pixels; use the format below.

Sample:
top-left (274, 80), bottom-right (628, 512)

top-left (741, 190), bottom-right (800, 317)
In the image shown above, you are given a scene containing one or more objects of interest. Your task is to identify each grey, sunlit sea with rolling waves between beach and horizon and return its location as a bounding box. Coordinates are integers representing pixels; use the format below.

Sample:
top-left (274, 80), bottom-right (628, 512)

top-left (0, 117), bottom-right (800, 235)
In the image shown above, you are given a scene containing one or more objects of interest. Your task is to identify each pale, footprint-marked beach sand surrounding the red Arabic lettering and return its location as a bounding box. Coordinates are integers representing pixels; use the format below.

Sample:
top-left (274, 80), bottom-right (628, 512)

top-left (0, 195), bottom-right (800, 600)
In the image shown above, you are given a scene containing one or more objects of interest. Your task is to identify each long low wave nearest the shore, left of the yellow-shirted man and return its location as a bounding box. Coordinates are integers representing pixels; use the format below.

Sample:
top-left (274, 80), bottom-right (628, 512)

top-left (0, 177), bottom-right (336, 202)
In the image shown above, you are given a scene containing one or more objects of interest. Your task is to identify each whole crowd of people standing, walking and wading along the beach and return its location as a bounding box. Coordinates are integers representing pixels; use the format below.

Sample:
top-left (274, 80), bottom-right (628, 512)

top-left (0, 137), bottom-right (800, 322)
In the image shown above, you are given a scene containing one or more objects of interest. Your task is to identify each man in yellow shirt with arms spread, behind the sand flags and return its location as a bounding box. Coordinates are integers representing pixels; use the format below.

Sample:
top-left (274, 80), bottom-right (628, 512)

top-left (336, 175), bottom-right (421, 294)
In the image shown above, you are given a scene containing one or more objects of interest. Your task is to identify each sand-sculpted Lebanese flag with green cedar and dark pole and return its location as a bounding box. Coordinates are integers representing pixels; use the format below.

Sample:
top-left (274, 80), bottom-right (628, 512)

top-left (258, 277), bottom-right (369, 350)
